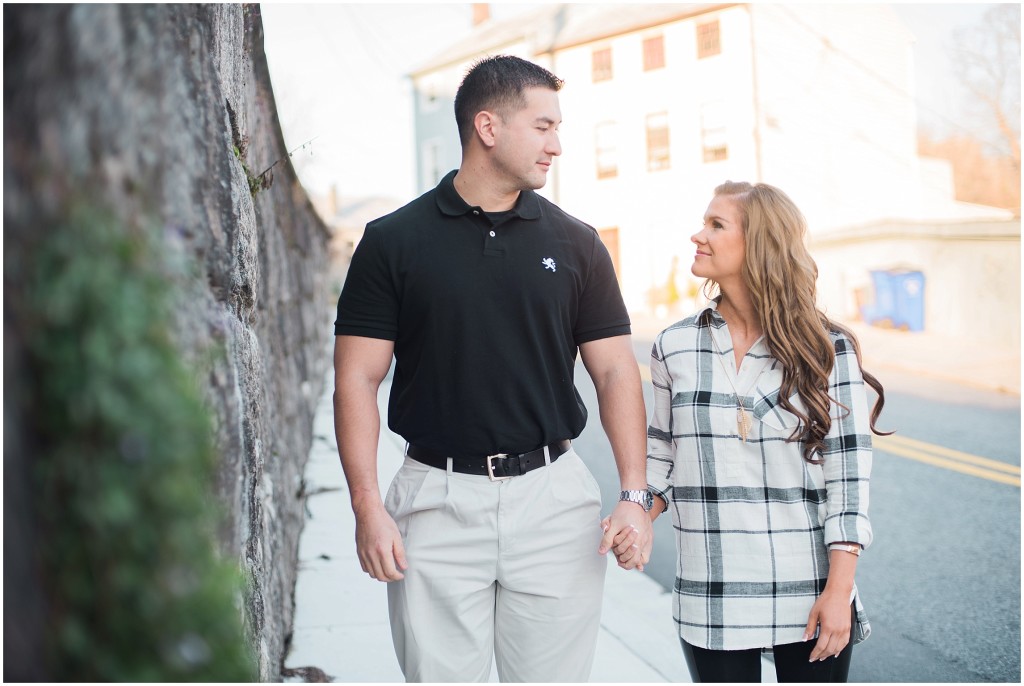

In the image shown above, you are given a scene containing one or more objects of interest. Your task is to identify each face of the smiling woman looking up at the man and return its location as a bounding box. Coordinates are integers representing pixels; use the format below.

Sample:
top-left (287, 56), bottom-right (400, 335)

top-left (690, 196), bottom-right (746, 287)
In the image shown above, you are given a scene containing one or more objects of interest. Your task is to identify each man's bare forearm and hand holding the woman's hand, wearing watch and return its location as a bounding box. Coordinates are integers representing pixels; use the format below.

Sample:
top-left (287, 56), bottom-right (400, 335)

top-left (580, 336), bottom-right (653, 571)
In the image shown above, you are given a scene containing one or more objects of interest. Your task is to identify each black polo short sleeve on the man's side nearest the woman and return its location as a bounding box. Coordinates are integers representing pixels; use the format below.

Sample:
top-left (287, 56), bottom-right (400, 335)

top-left (572, 231), bottom-right (631, 345)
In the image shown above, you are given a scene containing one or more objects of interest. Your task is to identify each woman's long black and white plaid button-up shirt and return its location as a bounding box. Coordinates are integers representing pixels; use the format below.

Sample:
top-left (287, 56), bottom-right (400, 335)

top-left (647, 302), bottom-right (871, 650)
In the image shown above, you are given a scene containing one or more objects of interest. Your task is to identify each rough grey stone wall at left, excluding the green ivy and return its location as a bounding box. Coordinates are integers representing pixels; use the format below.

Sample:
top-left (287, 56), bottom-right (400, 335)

top-left (3, 4), bottom-right (330, 680)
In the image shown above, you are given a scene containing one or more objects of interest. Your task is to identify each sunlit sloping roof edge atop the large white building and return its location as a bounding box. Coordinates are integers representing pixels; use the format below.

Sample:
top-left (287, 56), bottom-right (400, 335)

top-left (410, 3), bottom-right (739, 78)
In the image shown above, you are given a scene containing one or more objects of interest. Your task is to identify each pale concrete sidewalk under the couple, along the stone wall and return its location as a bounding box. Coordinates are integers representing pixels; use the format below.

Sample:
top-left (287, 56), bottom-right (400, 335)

top-left (285, 364), bottom-right (704, 683)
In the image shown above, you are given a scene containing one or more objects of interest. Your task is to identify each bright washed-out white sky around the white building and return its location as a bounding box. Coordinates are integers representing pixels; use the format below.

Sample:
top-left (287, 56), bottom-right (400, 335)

top-left (260, 2), bottom-right (1007, 203)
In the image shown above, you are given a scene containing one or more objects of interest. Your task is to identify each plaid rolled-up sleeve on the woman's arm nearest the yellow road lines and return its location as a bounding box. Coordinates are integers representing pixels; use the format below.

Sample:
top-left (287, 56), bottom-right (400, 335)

top-left (823, 335), bottom-right (872, 548)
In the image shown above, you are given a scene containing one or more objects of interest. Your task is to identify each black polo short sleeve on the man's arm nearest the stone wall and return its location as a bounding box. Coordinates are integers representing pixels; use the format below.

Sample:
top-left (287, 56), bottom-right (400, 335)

top-left (334, 223), bottom-right (400, 341)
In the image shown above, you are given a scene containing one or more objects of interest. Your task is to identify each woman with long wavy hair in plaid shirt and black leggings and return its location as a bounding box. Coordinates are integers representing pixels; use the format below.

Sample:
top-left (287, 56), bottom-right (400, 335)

top-left (638, 182), bottom-right (885, 682)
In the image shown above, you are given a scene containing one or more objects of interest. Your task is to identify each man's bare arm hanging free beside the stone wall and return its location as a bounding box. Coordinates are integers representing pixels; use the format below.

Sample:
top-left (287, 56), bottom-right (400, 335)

top-left (334, 336), bottom-right (408, 582)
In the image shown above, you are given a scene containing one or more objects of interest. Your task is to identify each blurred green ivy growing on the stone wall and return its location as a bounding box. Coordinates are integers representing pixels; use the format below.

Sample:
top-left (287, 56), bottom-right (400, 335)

top-left (14, 205), bottom-right (255, 682)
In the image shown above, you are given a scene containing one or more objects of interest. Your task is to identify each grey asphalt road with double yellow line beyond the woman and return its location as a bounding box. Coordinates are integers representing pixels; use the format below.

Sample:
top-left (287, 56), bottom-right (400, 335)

top-left (575, 342), bottom-right (1021, 683)
